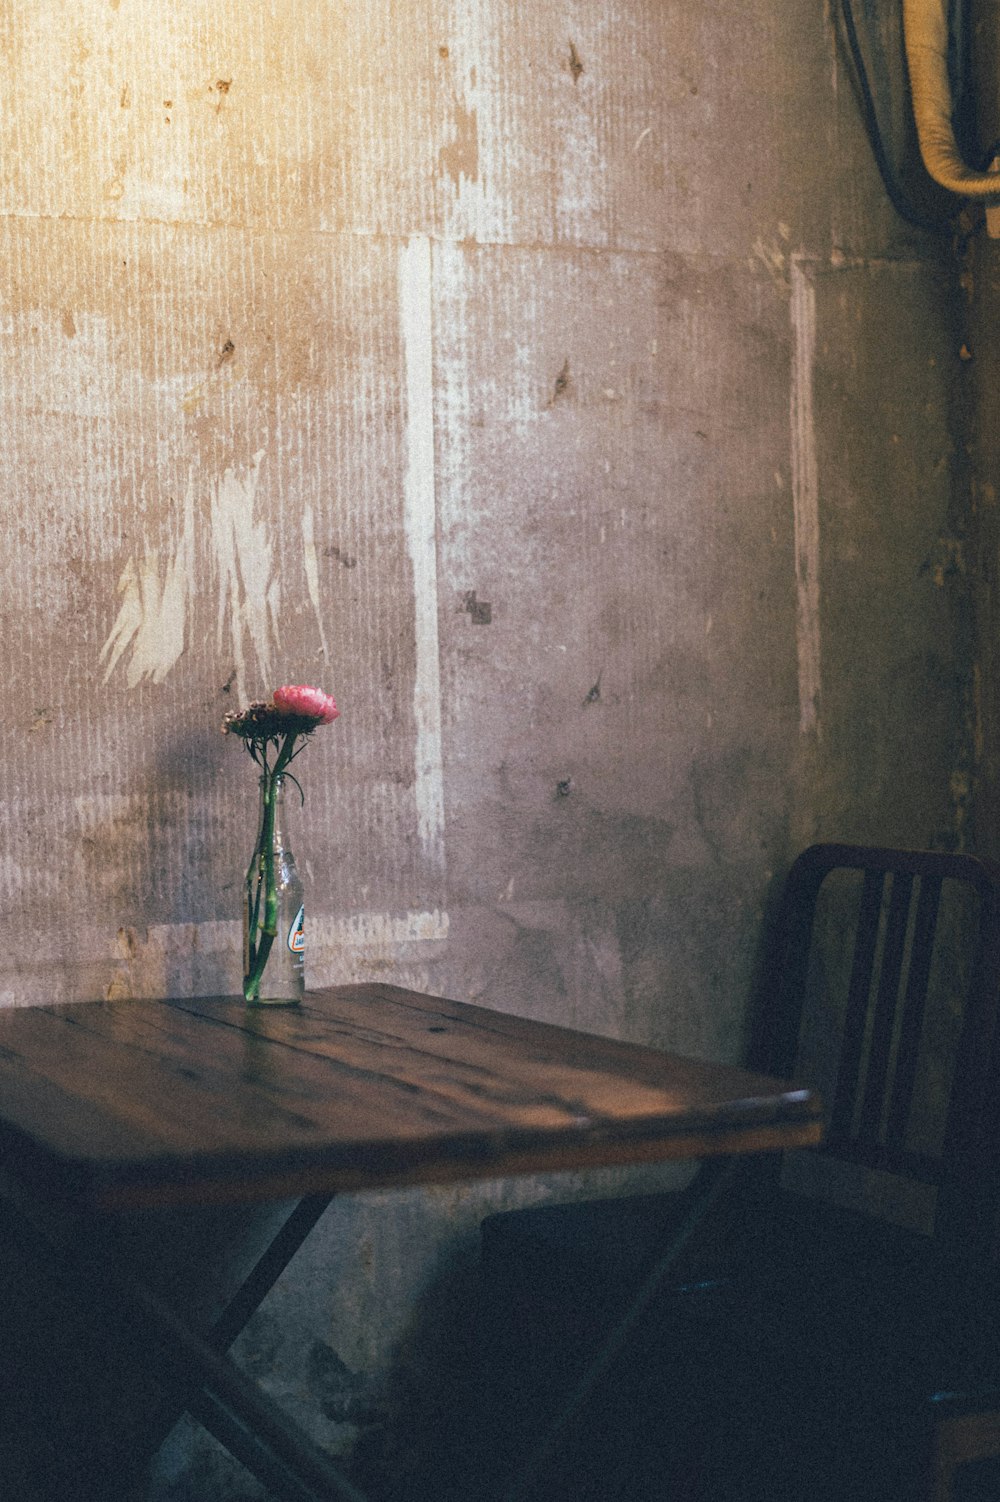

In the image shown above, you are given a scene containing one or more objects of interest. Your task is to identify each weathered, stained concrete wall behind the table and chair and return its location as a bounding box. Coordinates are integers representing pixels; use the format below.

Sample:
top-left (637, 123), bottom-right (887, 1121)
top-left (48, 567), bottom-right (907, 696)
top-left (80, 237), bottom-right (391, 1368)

top-left (0, 0), bottom-right (974, 1499)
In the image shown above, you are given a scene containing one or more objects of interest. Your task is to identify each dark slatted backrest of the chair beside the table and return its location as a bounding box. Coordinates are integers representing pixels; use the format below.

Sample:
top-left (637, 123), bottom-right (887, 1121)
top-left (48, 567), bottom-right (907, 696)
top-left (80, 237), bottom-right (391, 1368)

top-left (752, 844), bottom-right (1000, 1257)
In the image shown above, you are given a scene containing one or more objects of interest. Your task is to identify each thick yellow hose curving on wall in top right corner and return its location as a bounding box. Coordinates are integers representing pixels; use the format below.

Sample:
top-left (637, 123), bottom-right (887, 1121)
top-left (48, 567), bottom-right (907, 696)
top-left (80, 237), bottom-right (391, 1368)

top-left (902, 0), bottom-right (1000, 198)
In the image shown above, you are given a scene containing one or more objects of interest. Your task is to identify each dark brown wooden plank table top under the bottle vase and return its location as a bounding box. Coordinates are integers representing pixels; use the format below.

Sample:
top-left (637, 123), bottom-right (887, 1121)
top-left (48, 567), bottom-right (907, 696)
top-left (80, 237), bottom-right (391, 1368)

top-left (0, 984), bottom-right (820, 1211)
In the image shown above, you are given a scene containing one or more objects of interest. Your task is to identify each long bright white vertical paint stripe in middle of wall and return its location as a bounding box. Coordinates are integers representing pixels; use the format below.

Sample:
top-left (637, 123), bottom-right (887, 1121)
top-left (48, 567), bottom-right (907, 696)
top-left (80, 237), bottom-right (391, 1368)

top-left (399, 234), bottom-right (444, 873)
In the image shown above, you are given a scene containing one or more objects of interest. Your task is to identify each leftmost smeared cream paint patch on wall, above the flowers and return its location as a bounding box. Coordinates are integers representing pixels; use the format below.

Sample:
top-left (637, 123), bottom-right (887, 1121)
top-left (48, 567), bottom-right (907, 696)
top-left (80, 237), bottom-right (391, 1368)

top-left (101, 484), bottom-right (194, 688)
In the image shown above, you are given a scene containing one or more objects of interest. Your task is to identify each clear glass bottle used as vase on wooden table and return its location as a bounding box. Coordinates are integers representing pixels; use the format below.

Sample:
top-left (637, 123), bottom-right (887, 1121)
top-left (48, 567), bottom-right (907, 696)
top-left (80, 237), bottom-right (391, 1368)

top-left (243, 777), bottom-right (305, 1006)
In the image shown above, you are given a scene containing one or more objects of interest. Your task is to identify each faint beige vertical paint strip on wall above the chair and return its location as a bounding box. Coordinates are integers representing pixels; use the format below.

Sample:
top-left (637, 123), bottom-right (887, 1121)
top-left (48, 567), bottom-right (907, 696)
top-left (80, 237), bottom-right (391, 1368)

top-left (791, 257), bottom-right (820, 737)
